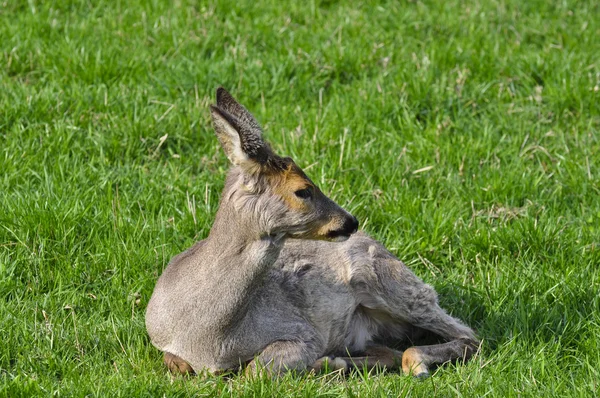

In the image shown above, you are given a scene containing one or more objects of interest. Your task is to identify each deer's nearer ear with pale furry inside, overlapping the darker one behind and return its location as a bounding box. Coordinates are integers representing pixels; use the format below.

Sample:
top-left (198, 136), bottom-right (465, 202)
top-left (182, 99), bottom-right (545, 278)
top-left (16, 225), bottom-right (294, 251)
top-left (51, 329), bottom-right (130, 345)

top-left (210, 105), bottom-right (272, 168)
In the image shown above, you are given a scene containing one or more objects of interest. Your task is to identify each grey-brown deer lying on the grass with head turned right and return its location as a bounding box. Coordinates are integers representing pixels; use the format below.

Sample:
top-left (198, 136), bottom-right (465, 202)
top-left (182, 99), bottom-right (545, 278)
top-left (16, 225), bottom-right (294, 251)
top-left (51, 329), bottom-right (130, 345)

top-left (146, 88), bottom-right (478, 376)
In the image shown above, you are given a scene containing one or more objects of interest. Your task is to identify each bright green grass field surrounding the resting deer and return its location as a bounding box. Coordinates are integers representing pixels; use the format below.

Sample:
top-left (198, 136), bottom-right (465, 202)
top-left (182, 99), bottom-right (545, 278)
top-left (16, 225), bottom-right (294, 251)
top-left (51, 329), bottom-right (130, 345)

top-left (0, 0), bottom-right (600, 397)
